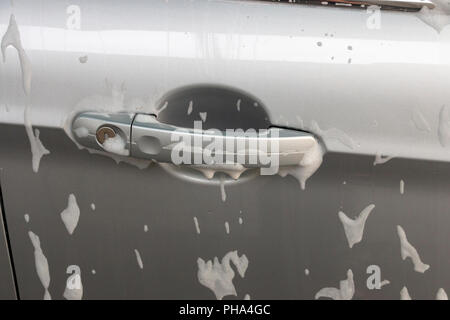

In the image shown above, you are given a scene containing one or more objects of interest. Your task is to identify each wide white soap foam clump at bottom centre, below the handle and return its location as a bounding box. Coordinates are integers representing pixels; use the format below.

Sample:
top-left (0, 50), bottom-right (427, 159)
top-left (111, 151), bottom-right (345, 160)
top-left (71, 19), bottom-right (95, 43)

top-left (197, 251), bottom-right (248, 300)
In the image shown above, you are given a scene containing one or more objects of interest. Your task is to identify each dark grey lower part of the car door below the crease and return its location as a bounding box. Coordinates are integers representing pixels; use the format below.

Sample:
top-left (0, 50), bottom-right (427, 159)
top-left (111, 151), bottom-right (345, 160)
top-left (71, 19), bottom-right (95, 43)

top-left (0, 126), bottom-right (450, 299)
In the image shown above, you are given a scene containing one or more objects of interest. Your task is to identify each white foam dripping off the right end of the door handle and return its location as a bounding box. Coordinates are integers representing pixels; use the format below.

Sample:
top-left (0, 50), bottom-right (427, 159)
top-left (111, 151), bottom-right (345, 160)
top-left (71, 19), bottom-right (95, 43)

top-left (278, 143), bottom-right (324, 190)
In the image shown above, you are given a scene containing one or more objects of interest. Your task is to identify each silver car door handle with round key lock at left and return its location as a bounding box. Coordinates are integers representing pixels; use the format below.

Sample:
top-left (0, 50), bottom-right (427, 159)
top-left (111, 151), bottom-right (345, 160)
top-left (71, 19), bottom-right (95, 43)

top-left (72, 112), bottom-right (318, 169)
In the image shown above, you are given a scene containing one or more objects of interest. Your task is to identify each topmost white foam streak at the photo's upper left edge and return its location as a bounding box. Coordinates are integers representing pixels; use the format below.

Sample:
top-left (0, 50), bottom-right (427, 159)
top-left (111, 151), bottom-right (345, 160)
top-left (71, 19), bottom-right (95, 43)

top-left (1, 14), bottom-right (32, 95)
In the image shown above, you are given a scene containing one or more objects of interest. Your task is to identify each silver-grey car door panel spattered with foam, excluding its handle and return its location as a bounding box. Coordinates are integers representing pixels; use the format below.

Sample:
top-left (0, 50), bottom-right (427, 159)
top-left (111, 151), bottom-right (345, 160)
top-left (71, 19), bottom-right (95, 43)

top-left (0, 0), bottom-right (450, 299)
